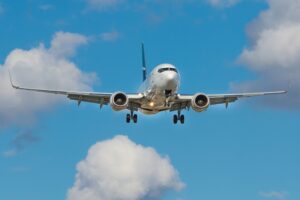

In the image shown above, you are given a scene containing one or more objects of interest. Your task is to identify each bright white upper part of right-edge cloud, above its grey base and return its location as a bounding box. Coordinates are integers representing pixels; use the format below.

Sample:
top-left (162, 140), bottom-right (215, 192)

top-left (241, 0), bottom-right (300, 70)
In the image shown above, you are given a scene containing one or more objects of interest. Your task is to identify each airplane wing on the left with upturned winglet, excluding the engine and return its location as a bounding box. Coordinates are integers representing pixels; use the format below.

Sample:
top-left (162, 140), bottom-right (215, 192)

top-left (10, 73), bottom-right (143, 110)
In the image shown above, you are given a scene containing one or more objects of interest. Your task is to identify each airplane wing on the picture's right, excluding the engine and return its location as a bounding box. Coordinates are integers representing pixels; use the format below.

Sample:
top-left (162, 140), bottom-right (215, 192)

top-left (171, 91), bottom-right (287, 111)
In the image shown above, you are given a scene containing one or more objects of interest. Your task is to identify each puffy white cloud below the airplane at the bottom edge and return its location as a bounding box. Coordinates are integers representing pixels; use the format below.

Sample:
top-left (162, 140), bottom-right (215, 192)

top-left (67, 136), bottom-right (184, 200)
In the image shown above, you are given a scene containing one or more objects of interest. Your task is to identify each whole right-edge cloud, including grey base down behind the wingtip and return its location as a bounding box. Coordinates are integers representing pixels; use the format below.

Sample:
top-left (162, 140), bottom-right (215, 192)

top-left (234, 0), bottom-right (300, 109)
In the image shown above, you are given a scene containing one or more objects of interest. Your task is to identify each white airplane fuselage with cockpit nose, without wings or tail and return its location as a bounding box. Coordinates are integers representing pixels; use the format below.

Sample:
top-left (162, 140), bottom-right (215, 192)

top-left (140, 64), bottom-right (180, 114)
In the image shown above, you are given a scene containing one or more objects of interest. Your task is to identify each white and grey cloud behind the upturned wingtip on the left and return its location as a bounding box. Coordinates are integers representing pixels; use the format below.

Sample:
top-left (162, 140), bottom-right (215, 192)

top-left (0, 32), bottom-right (95, 127)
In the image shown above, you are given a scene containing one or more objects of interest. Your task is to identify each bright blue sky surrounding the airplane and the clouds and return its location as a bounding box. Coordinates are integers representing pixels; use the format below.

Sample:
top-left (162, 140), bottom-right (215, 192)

top-left (0, 0), bottom-right (300, 200)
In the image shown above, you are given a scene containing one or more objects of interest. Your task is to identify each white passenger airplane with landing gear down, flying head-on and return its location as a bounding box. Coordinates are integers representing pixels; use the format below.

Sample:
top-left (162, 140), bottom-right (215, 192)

top-left (9, 43), bottom-right (287, 124)
